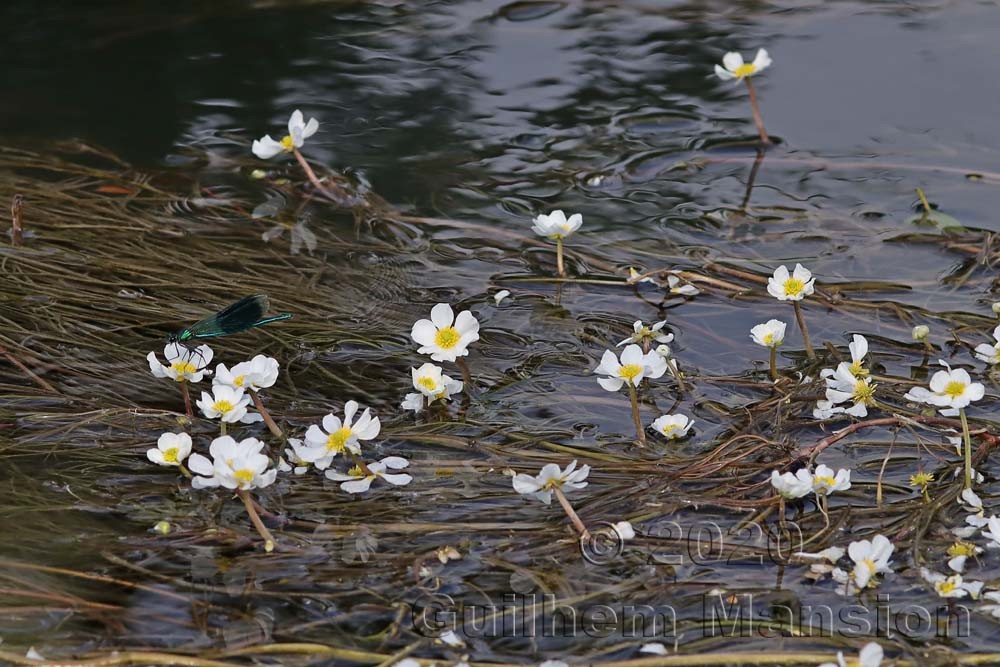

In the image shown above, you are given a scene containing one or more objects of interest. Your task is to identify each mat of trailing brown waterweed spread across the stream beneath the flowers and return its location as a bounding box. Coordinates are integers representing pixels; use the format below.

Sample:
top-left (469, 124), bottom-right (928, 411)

top-left (0, 138), bottom-right (998, 665)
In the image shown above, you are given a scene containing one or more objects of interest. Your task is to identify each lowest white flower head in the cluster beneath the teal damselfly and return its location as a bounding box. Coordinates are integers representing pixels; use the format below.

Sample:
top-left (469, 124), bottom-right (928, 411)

top-left (188, 435), bottom-right (278, 490)
